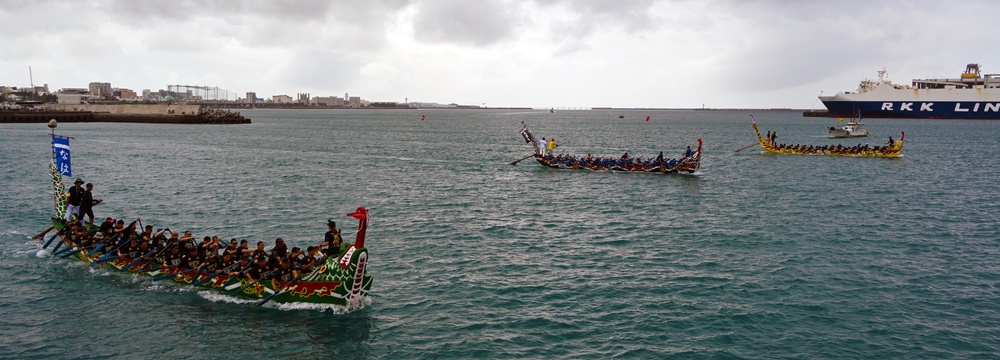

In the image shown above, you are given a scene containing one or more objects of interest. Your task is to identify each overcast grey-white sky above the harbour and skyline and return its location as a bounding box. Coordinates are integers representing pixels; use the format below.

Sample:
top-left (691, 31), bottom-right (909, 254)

top-left (0, 0), bottom-right (1000, 109)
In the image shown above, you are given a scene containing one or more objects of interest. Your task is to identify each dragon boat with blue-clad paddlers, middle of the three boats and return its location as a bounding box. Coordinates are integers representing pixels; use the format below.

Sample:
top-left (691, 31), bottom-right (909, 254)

top-left (511, 123), bottom-right (702, 174)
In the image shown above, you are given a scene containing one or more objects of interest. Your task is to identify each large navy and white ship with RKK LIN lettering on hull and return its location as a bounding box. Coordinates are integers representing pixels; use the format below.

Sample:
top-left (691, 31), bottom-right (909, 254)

top-left (820, 64), bottom-right (1000, 120)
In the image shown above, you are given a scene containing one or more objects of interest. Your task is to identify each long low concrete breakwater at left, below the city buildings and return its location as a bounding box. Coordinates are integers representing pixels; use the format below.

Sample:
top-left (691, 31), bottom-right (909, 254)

top-left (0, 104), bottom-right (250, 124)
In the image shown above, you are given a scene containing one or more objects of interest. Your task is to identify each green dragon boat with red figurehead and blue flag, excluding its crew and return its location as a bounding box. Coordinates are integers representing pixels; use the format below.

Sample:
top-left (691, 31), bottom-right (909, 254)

top-left (36, 120), bottom-right (372, 310)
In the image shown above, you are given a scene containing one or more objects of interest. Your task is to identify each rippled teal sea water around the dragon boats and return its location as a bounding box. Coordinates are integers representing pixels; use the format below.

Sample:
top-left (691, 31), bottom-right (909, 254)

top-left (0, 110), bottom-right (1000, 359)
